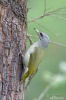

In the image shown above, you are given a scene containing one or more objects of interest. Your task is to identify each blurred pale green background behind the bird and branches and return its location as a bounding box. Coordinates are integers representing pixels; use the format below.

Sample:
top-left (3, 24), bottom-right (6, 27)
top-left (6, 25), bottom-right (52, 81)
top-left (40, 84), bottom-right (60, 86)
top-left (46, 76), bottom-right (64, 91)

top-left (25, 0), bottom-right (66, 100)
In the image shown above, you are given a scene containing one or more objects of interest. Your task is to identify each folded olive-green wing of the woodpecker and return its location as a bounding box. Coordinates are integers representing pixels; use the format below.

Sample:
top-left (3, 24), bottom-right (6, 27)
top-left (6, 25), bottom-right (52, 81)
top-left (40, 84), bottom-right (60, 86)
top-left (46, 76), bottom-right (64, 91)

top-left (28, 47), bottom-right (44, 76)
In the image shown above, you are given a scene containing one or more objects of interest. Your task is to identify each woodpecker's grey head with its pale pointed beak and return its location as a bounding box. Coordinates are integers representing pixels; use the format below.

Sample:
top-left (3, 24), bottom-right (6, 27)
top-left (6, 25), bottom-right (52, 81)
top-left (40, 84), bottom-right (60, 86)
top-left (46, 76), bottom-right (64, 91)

top-left (35, 29), bottom-right (50, 48)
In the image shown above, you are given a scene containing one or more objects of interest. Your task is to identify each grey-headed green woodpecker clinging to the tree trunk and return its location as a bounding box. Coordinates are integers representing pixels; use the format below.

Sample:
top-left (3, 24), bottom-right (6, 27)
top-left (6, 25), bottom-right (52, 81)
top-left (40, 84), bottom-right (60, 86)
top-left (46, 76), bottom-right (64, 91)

top-left (21, 28), bottom-right (50, 84)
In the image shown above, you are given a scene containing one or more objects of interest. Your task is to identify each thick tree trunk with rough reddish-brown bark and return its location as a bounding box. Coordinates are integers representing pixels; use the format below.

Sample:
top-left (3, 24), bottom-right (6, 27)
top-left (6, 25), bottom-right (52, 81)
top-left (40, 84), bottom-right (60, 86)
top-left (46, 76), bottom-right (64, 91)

top-left (0, 0), bottom-right (27, 100)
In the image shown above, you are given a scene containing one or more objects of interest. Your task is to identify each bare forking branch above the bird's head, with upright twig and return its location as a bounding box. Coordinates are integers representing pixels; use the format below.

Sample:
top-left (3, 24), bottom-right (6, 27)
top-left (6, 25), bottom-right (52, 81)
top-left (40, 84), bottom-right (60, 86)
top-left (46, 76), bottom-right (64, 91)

top-left (28, 0), bottom-right (66, 36)
